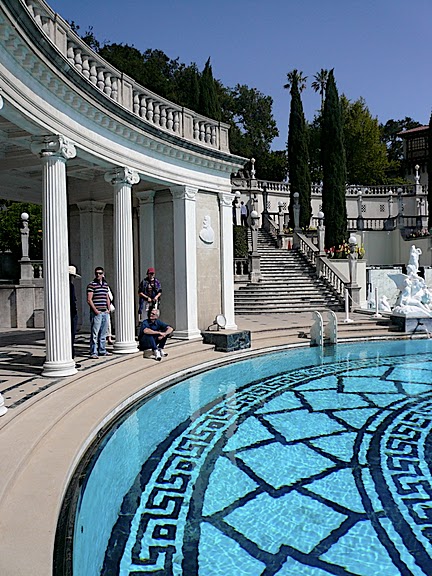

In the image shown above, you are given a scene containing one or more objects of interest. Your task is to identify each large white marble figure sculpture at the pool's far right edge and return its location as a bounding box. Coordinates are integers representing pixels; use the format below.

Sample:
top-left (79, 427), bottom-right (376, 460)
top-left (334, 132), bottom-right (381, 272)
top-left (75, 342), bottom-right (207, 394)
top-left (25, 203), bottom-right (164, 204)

top-left (389, 246), bottom-right (432, 318)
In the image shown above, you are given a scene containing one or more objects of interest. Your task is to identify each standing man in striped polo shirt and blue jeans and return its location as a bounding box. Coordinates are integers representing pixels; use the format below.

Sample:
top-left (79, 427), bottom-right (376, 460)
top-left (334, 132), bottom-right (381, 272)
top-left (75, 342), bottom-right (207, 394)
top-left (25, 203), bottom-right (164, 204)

top-left (87, 266), bottom-right (111, 358)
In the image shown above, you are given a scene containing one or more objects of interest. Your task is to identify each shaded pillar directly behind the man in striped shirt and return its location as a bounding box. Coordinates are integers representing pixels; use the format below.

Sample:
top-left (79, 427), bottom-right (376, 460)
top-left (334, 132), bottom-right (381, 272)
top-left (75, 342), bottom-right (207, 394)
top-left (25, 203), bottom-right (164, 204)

top-left (74, 200), bottom-right (105, 330)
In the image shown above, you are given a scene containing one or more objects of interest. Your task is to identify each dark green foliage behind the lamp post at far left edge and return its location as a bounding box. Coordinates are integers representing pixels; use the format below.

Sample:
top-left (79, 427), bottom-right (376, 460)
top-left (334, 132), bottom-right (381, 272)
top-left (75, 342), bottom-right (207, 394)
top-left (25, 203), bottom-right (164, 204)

top-left (0, 200), bottom-right (42, 260)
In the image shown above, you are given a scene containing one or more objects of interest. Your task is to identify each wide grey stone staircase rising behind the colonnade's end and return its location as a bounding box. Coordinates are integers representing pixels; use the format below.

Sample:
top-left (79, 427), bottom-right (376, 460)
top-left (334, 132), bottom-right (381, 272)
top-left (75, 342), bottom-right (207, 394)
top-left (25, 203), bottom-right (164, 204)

top-left (234, 230), bottom-right (343, 314)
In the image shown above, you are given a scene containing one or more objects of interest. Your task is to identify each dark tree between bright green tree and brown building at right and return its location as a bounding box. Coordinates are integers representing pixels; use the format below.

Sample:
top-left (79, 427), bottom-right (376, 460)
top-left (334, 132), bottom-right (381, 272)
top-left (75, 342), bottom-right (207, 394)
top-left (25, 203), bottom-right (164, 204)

top-left (380, 116), bottom-right (421, 184)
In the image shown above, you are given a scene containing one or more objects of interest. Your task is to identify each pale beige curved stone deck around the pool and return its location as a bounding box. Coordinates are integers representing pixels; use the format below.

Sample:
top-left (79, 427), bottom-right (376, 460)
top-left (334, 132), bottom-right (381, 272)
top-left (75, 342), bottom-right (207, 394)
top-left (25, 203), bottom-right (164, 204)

top-left (0, 313), bottom-right (416, 576)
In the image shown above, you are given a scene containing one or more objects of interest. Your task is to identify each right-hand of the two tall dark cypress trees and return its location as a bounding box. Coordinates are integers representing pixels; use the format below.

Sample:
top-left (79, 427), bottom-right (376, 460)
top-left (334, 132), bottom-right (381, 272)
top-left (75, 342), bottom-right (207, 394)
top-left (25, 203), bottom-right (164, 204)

top-left (321, 70), bottom-right (347, 248)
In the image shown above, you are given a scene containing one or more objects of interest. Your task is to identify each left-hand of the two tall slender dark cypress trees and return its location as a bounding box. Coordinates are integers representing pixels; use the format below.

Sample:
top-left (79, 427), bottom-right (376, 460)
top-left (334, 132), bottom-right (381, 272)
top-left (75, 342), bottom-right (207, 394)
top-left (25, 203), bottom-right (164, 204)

top-left (288, 76), bottom-right (312, 228)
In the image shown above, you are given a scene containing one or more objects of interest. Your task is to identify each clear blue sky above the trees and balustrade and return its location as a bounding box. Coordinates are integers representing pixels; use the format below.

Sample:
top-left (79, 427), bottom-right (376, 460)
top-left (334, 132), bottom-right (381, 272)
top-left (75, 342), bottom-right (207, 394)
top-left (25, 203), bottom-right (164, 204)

top-left (48, 0), bottom-right (432, 149)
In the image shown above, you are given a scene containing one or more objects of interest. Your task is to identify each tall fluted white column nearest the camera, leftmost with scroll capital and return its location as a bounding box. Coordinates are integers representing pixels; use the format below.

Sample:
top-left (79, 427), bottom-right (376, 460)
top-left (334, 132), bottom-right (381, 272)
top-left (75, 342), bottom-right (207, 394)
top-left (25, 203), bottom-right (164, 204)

top-left (32, 135), bottom-right (76, 377)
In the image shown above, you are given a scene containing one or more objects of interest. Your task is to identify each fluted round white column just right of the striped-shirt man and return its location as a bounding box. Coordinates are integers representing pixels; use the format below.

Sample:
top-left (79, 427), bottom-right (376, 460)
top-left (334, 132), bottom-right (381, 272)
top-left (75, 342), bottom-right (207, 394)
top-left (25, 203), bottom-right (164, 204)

top-left (105, 168), bottom-right (140, 354)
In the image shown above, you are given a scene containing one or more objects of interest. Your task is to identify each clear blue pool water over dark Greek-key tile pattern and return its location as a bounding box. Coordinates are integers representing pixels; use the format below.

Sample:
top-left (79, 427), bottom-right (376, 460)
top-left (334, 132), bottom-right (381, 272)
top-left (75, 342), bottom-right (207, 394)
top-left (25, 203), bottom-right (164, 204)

top-left (73, 340), bottom-right (432, 576)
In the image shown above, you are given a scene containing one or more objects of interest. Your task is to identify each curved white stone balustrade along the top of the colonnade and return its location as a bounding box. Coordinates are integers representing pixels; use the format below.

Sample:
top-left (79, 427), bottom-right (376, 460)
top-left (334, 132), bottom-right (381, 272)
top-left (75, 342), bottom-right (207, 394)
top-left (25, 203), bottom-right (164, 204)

top-left (21, 0), bottom-right (229, 152)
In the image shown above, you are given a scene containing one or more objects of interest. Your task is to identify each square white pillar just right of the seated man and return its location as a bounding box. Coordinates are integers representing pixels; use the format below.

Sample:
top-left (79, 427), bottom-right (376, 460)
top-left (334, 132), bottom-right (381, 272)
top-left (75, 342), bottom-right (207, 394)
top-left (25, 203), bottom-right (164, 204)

top-left (171, 186), bottom-right (201, 340)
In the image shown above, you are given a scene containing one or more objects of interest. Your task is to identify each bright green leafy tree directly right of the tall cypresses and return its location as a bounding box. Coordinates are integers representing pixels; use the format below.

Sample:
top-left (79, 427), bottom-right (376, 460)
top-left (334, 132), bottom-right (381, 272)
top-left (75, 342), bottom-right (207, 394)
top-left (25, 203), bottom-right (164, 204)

top-left (340, 96), bottom-right (388, 186)
